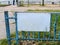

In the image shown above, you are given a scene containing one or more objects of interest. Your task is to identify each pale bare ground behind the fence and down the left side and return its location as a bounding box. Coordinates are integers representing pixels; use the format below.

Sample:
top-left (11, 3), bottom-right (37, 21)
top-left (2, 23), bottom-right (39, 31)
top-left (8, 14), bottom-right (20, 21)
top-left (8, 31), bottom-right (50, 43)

top-left (0, 5), bottom-right (60, 39)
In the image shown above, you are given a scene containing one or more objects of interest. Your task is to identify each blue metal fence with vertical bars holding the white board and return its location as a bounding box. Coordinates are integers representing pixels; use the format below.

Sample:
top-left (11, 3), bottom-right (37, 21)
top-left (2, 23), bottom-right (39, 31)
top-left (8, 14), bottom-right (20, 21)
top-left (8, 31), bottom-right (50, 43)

top-left (4, 11), bottom-right (60, 45)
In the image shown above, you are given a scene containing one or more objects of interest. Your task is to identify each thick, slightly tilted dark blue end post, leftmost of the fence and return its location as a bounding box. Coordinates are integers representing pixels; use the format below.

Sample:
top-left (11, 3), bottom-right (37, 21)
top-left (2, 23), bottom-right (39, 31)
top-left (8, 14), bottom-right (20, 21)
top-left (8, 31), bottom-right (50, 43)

top-left (4, 11), bottom-right (11, 45)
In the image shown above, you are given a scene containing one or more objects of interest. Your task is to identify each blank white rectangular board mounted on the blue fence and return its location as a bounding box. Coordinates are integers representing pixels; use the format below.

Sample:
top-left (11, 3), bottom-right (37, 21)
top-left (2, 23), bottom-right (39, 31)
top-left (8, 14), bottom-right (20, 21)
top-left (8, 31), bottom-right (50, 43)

top-left (17, 13), bottom-right (51, 32)
